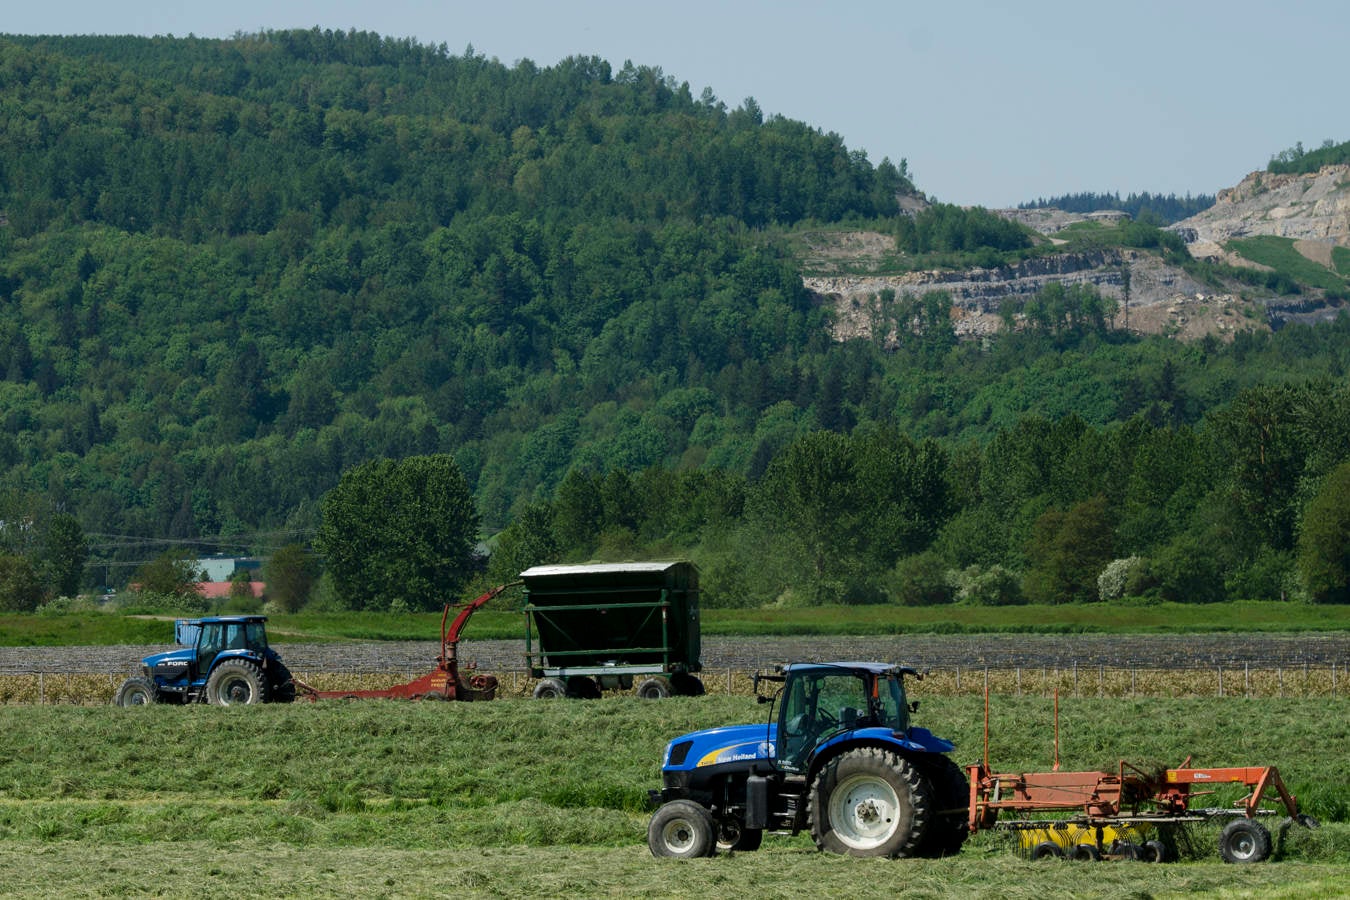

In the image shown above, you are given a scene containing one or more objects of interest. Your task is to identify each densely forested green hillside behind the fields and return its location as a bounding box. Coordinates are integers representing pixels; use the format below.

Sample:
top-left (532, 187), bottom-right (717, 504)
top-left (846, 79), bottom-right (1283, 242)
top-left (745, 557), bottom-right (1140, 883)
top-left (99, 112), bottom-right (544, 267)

top-left (0, 30), bottom-right (1350, 609)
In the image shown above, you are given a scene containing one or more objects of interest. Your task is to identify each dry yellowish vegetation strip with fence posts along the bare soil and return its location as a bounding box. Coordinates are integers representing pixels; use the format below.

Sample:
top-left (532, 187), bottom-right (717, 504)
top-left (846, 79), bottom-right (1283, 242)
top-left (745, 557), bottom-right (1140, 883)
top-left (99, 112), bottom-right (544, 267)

top-left (0, 663), bottom-right (1347, 706)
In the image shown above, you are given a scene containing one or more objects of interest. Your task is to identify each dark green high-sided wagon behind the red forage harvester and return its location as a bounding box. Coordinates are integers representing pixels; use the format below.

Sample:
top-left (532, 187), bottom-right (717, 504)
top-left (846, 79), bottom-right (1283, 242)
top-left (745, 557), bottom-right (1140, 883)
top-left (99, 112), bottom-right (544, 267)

top-left (520, 560), bottom-right (703, 699)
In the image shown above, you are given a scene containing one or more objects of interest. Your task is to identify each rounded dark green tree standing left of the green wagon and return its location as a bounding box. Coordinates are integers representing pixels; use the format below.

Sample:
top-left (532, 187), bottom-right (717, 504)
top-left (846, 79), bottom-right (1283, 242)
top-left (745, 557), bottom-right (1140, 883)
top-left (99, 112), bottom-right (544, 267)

top-left (315, 453), bottom-right (478, 610)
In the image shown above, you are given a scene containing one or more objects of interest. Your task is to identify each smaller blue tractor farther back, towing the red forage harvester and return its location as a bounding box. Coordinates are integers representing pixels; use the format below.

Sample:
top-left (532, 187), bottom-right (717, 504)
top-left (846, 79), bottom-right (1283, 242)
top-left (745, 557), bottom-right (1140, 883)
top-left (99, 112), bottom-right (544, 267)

top-left (112, 615), bottom-right (296, 706)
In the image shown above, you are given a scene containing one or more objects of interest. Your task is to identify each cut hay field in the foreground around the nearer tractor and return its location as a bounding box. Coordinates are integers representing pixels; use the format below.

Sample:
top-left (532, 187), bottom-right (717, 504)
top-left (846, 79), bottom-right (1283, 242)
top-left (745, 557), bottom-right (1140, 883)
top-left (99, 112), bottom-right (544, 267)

top-left (0, 684), bottom-right (1350, 897)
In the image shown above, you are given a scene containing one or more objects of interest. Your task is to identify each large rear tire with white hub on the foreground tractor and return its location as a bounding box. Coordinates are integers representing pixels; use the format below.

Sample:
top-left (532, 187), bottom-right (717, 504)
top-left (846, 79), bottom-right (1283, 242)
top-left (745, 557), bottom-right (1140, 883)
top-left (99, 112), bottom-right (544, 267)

top-left (809, 748), bottom-right (933, 858)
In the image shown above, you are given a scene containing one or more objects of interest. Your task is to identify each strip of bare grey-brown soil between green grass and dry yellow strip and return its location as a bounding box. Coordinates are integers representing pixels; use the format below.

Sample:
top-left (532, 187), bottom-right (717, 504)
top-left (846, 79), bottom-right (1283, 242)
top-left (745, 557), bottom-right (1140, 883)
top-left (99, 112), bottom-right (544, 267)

top-left (0, 633), bottom-right (1350, 675)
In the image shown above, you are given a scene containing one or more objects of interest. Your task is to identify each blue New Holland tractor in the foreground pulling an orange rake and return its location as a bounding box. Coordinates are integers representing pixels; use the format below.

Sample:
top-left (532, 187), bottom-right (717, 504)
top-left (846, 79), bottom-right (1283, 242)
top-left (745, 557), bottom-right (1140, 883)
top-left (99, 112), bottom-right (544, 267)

top-left (647, 663), bottom-right (971, 858)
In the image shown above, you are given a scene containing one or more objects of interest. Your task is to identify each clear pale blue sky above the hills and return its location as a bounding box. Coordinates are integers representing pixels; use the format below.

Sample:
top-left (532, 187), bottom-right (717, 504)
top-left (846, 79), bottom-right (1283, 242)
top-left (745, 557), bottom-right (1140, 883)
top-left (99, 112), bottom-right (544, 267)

top-left (0, 0), bottom-right (1350, 206)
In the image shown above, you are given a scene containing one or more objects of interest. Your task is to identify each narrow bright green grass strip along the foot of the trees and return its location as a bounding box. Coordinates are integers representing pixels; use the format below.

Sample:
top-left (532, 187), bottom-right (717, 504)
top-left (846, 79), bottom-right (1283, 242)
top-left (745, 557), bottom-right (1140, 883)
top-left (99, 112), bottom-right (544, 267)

top-left (0, 600), bottom-right (1350, 646)
